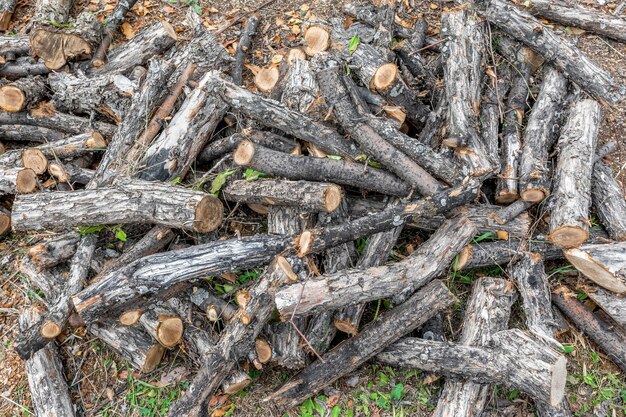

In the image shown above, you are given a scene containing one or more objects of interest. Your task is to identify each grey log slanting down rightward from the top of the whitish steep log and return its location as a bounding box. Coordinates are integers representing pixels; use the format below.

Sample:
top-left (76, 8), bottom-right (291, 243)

top-left (206, 72), bottom-right (359, 158)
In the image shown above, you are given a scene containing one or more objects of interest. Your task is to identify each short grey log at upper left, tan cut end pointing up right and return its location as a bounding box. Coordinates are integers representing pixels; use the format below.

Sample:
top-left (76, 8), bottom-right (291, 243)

top-left (94, 21), bottom-right (178, 75)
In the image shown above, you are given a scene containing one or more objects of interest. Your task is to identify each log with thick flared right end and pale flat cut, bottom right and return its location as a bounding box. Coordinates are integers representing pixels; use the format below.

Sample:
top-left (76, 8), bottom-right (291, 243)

top-left (376, 329), bottom-right (567, 404)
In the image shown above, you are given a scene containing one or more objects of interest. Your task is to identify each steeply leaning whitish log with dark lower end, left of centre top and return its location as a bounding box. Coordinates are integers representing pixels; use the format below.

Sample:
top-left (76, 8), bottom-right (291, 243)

top-left (138, 70), bottom-right (227, 181)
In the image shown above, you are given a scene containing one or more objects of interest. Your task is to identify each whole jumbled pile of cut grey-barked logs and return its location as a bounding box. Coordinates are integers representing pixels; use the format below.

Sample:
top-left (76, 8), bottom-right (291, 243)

top-left (0, 0), bottom-right (626, 417)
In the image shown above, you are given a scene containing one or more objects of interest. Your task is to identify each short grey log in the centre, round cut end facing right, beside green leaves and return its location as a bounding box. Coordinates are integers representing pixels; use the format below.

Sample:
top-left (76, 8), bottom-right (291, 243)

top-left (222, 179), bottom-right (343, 212)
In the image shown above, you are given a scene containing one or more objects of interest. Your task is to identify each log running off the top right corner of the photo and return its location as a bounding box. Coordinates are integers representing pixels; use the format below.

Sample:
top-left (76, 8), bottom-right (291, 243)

top-left (524, 0), bottom-right (626, 43)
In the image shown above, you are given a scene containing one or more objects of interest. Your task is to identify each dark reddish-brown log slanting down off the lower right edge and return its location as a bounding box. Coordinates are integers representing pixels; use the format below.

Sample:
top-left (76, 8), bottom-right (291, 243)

top-left (552, 286), bottom-right (626, 371)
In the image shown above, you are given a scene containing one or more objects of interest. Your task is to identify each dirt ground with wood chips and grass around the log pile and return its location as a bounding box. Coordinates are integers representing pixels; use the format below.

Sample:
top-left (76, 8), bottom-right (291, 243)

top-left (0, 0), bottom-right (626, 417)
